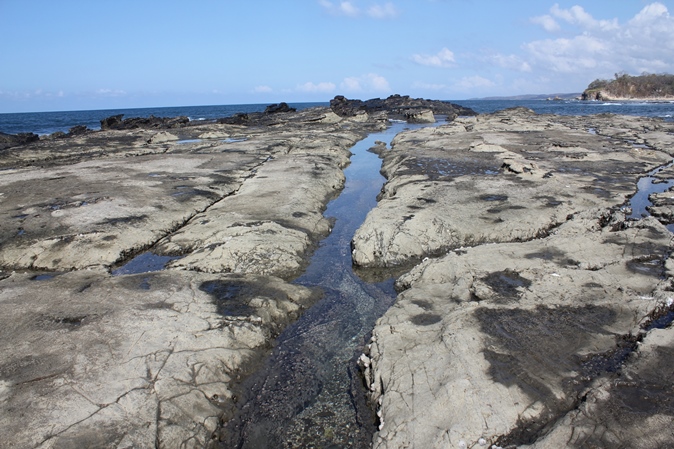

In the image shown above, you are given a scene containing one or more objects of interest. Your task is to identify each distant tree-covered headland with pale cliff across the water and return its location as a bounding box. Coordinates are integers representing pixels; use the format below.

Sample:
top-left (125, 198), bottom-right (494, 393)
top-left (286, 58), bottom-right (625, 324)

top-left (581, 72), bottom-right (674, 100)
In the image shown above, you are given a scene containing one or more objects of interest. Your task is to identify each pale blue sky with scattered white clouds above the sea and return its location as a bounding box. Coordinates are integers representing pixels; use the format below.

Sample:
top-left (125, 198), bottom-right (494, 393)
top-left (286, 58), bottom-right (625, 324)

top-left (0, 0), bottom-right (674, 113)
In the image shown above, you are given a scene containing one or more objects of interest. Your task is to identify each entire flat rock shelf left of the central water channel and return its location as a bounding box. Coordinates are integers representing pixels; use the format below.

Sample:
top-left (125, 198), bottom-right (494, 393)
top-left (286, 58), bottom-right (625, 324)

top-left (0, 108), bottom-right (386, 448)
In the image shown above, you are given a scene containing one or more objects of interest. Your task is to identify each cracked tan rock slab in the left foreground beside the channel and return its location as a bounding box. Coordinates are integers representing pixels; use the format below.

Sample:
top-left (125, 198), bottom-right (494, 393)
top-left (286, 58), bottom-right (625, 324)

top-left (0, 271), bottom-right (310, 448)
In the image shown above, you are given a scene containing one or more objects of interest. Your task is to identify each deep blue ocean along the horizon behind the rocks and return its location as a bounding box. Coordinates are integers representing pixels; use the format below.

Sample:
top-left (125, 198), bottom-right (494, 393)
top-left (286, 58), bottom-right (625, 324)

top-left (0, 100), bottom-right (674, 135)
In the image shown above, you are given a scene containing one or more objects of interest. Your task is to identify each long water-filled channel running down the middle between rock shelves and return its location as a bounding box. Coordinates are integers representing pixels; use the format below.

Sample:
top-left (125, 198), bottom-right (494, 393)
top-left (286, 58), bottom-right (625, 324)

top-left (222, 123), bottom-right (436, 449)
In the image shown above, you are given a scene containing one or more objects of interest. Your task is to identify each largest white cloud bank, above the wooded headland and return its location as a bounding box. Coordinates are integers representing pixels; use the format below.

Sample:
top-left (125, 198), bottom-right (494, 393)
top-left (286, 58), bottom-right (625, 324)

top-left (486, 2), bottom-right (674, 90)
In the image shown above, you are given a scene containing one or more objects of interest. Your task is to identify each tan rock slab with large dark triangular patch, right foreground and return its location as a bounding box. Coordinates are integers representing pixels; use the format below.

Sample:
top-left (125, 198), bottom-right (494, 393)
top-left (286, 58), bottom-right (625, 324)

top-left (366, 212), bottom-right (671, 448)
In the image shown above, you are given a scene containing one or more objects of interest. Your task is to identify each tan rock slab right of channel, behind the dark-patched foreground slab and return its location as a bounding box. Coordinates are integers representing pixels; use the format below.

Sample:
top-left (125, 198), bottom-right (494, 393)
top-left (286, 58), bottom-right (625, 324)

top-left (353, 110), bottom-right (670, 267)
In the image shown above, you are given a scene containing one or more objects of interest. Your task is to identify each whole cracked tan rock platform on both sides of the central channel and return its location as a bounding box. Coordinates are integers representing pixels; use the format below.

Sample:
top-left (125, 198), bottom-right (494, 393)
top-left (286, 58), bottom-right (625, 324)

top-left (0, 96), bottom-right (674, 449)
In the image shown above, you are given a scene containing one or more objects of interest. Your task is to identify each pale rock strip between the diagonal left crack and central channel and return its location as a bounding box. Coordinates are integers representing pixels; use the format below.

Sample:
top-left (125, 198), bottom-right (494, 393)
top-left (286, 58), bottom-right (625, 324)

top-left (156, 130), bottom-right (357, 277)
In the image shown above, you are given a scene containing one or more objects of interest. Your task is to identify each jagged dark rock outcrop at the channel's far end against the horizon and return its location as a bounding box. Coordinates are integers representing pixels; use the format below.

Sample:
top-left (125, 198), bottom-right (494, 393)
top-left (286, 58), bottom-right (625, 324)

top-left (330, 95), bottom-right (477, 120)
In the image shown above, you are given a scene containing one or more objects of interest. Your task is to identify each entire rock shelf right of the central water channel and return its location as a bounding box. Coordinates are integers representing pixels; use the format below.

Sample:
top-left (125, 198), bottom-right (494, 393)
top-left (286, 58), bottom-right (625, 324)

top-left (352, 109), bottom-right (674, 448)
